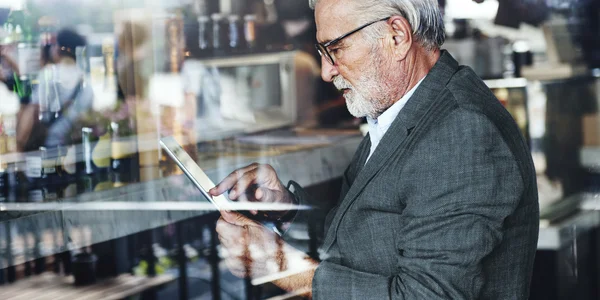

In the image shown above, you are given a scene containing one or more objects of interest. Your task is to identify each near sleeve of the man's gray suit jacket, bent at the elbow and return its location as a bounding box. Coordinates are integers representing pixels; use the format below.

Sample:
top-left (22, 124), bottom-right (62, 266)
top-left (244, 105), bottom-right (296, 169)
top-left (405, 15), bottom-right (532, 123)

top-left (313, 109), bottom-right (524, 300)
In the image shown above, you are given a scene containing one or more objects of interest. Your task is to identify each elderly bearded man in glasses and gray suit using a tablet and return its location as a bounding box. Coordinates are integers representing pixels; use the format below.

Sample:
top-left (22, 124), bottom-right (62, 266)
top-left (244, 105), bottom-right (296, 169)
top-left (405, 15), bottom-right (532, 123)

top-left (211, 0), bottom-right (539, 299)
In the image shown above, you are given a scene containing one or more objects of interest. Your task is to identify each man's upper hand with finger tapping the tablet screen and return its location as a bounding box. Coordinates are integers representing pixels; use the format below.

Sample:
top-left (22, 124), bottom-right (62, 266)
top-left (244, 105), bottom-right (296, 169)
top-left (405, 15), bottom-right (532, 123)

top-left (208, 163), bottom-right (294, 218)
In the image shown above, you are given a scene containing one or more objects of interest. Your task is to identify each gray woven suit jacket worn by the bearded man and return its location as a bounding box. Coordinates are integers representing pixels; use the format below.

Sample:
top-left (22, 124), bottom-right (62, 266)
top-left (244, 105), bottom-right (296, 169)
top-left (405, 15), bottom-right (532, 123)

top-left (313, 51), bottom-right (539, 300)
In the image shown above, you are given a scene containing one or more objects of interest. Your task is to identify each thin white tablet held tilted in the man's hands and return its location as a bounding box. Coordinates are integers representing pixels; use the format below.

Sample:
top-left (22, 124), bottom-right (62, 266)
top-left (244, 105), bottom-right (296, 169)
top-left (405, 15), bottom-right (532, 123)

top-left (160, 137), bottom-right (231, 210)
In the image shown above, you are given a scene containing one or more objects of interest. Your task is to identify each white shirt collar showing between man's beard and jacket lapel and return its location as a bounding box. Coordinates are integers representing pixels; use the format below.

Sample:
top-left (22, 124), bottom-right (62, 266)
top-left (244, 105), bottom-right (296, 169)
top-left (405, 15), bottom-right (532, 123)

top-left (367, 78), bottom-right (425, 162)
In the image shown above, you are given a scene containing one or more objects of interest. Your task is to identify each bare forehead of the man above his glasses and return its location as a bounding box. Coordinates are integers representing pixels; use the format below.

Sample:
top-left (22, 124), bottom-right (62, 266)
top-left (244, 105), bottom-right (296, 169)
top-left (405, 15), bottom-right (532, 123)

top-left (315, 0), bottom-right (356, 43)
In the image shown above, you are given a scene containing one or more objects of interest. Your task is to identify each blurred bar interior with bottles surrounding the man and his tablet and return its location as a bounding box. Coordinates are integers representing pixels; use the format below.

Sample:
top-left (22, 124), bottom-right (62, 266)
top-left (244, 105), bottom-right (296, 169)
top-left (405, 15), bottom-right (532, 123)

top-left (0, 0), bottom-right (600, 299)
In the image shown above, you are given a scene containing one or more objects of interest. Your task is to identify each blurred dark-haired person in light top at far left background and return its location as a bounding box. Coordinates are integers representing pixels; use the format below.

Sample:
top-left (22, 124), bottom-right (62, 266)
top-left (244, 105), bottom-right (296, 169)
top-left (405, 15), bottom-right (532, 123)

top-left (17, 29), bottom-right (94, 151)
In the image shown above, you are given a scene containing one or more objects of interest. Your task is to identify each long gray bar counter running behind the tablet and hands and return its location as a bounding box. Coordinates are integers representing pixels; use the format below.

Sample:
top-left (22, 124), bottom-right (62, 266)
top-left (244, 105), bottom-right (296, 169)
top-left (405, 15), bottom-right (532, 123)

top-left (0, 132), bottom-right (362, 269)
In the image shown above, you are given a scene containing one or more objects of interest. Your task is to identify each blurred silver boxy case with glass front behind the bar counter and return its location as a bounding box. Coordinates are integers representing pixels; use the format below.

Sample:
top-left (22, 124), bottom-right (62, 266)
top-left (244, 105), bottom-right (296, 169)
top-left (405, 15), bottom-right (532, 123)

top-left (180, 51), bottom-right (304, 141)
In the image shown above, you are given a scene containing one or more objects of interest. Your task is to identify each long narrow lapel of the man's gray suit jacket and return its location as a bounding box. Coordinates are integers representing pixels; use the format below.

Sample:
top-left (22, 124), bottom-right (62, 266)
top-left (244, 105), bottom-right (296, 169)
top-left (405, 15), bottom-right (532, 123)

top-left (323, 51), bottom-right (458, 252)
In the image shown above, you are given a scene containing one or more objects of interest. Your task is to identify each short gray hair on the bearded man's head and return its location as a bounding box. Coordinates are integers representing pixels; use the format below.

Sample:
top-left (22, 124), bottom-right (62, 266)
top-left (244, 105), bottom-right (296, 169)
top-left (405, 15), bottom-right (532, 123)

top-left (309, 0), bottom-right (446, 51)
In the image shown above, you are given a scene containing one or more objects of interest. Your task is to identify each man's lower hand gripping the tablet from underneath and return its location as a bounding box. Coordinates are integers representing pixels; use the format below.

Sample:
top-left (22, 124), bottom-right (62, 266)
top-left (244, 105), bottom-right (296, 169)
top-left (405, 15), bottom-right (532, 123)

top-left (217, 212), bottom-right (314, 279)
